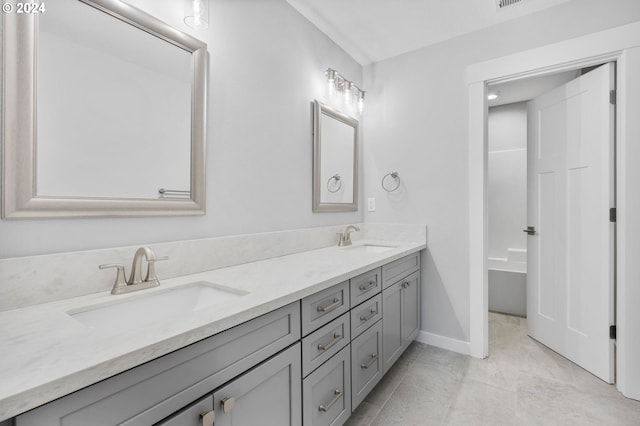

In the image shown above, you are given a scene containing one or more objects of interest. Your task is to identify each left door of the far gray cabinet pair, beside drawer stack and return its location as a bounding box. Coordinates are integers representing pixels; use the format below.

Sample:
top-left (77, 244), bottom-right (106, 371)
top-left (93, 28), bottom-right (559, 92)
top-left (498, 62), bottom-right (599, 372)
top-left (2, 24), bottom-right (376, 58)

top-left (382, 281), bottom-right (403, 373)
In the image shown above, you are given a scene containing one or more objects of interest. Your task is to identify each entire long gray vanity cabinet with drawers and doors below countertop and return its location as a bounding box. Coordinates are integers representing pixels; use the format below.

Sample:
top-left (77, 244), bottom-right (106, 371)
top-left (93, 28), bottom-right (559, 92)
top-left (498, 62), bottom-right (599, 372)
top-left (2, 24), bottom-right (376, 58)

top-left (11, 253), bottom-right (420, 426)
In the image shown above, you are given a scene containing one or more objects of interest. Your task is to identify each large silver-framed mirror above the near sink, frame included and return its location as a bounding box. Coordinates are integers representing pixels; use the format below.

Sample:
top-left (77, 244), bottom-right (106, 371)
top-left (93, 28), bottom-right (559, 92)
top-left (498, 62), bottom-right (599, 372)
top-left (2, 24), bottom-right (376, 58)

top-left (2, 0), bottom-right (208, 219)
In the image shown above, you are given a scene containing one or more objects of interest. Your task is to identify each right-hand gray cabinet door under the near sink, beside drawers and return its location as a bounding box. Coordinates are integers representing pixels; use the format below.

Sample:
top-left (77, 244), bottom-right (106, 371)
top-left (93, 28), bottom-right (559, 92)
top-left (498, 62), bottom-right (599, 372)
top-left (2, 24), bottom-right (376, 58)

top-left (213, 343), bottom-right (302, 426)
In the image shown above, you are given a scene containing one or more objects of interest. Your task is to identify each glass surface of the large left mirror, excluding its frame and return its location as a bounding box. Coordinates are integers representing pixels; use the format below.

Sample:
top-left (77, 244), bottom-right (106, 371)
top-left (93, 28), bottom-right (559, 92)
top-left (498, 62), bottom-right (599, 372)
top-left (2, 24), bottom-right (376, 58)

top-left (36, 0), bottom-right (191, 198)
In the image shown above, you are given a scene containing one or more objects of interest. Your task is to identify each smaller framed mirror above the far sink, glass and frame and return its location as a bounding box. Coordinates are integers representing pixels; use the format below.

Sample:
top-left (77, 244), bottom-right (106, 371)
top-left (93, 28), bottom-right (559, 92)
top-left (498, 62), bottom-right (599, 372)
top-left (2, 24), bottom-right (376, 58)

top-left (313, 100), bottom-right (359, 212)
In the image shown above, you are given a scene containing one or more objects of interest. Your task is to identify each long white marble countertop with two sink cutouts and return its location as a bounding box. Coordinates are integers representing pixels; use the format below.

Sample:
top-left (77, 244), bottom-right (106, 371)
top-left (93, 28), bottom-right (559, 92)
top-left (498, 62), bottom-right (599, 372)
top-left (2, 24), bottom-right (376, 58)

top-left (0, 241), bottom-right (426, 421)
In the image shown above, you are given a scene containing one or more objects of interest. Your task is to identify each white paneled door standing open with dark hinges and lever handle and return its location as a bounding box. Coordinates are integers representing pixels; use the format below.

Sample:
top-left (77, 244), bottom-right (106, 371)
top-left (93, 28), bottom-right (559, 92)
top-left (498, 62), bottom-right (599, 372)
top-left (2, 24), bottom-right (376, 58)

top-left (527, 64), bottom-right (615, 383)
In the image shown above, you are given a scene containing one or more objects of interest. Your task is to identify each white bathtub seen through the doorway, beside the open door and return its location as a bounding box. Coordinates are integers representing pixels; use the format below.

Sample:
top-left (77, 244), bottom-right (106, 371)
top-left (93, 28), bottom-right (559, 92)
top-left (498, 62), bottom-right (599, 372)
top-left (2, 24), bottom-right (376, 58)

top-left (488, 249), bottom-right (527, 317)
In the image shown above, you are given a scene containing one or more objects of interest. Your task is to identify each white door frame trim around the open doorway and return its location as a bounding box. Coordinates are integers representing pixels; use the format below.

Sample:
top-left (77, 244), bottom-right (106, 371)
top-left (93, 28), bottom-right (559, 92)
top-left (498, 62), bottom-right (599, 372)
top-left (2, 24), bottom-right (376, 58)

top-left (467, 22), bottom-right (640, 399)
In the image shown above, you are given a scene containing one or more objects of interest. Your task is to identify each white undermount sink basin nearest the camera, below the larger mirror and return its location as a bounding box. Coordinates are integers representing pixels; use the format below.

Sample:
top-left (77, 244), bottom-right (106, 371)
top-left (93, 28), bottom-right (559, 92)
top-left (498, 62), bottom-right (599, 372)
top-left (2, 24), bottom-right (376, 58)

top-left (67, 281), bottom-right (249, 328)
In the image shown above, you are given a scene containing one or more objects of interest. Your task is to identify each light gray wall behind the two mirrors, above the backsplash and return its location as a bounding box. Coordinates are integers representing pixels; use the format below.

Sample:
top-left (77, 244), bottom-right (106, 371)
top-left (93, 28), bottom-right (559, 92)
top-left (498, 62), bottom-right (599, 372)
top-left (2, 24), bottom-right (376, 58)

top-left (0, 0), bottom-right (363, 258)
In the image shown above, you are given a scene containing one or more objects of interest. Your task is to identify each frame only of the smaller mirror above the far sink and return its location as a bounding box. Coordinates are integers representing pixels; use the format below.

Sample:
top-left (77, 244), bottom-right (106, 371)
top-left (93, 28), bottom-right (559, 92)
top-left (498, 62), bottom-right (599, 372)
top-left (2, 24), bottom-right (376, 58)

top-left (312, 100), bottom-right (359, 212)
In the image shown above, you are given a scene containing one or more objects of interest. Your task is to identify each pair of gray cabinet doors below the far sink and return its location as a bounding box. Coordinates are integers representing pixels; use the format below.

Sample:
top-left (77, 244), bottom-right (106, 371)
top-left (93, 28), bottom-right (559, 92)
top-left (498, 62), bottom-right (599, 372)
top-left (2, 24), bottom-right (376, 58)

top-left (382, 271), bottom-right (420, 373)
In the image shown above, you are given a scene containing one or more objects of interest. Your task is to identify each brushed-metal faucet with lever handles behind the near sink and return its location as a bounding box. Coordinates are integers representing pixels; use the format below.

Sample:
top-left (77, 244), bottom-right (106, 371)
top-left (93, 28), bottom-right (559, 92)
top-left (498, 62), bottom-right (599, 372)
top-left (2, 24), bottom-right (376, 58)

top-left (99, 247), bottom-right (169, 294)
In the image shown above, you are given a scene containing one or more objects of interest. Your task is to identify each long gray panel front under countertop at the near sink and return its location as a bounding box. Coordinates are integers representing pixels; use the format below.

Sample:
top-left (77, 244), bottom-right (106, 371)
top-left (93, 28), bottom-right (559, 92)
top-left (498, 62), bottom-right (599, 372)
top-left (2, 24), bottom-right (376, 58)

top-left (16, 302), bottom-right (300, 426)
